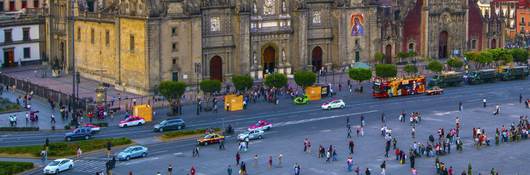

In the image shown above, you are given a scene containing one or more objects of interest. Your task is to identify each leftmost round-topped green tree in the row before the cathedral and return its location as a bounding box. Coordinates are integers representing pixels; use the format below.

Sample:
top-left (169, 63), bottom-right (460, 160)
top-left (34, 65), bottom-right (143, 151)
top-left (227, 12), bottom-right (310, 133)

top-left (158, 81), bottom-right (186, 115)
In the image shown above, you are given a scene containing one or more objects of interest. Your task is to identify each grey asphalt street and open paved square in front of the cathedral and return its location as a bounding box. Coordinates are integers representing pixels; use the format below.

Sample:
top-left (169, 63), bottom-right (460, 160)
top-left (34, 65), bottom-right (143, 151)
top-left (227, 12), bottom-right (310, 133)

top-left (16, 80), bottom-right (530, 175)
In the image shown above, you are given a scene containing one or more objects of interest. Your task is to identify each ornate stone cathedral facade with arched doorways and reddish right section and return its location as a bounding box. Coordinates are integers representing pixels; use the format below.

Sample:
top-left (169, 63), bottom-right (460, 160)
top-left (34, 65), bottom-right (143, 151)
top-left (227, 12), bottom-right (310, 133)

top-left (50, 0), bottom-right (504, 94)
